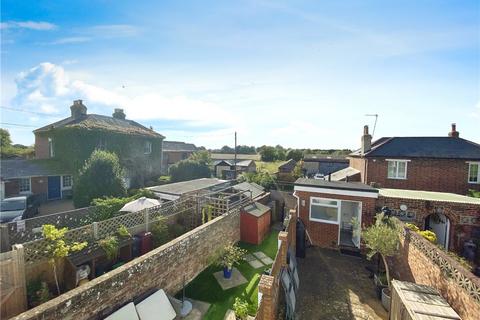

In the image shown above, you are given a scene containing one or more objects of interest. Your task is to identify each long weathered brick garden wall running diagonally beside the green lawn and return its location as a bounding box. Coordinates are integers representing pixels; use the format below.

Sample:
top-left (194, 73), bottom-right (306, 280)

top-left (15, 209), bottom-right (240, 320)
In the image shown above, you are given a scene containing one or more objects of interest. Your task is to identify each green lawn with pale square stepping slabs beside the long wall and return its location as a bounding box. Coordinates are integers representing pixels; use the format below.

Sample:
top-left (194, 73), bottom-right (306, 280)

top-left (186, 230), bottom-right (278, 320)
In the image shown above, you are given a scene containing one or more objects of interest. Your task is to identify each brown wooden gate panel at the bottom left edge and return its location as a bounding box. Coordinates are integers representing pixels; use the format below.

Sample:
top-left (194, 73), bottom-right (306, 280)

top-left (0, 245), bottom-right (27, 319)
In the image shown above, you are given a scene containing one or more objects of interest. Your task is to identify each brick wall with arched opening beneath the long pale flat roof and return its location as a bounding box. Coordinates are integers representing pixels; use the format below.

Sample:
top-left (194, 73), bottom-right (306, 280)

top-left (377, 196), bottom-right (480, 253)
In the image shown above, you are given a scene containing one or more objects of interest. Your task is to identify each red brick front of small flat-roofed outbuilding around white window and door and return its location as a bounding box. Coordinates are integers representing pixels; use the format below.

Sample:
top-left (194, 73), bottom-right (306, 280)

top-left (296, 191), bottom-right (376, 247)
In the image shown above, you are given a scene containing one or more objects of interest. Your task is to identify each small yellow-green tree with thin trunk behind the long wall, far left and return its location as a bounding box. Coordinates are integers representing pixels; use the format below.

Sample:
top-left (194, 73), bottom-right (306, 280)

top-left (42, 224), bottom-right (87, 295)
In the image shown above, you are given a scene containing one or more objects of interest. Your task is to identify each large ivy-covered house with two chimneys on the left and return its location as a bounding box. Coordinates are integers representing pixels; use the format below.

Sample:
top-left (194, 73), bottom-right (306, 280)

top-left (33, 100), bottom-right (164, 187)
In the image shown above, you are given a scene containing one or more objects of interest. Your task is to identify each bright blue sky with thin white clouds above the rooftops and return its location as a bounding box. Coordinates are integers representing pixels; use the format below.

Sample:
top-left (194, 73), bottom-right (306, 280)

top-left (0, 0), bottom-right (480, 149)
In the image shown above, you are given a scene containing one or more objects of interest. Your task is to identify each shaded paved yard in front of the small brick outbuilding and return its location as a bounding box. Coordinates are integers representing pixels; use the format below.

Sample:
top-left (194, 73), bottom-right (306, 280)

top-left (296, 248), bottom-right (388, 320)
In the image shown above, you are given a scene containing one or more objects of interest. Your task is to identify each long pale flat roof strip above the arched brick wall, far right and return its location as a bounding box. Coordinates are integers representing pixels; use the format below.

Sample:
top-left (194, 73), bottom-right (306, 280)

top-left (379, 188), bottom-right (480, 205)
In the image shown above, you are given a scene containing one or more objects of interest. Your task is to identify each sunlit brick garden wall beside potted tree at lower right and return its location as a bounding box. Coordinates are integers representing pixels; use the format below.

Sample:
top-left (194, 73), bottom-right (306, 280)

top-left (391, 229), bottom-right (480, 320)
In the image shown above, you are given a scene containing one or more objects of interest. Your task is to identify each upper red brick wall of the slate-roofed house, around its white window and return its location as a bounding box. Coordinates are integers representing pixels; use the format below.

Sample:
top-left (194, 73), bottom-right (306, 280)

top-left (350, 158), bottom-right (480, 194)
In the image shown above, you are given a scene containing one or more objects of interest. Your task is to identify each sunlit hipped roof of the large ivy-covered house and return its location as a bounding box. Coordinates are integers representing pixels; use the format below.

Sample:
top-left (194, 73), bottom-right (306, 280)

top-left (33, 114), bottom-right (165, 138)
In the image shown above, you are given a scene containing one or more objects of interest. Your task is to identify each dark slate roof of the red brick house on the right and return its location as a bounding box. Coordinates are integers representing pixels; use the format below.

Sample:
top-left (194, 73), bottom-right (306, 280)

top-left (350, 137), bottom-right (480, 160)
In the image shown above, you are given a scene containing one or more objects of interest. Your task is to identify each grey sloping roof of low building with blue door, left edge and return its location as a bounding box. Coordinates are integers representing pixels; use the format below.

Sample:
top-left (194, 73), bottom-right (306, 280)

top-left (0, 159), bottom-right (70, 180)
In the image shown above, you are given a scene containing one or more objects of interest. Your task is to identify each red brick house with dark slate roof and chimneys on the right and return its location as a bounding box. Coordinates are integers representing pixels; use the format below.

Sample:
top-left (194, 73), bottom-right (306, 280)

top-left (331, 124), bottom-right (480, 194)
